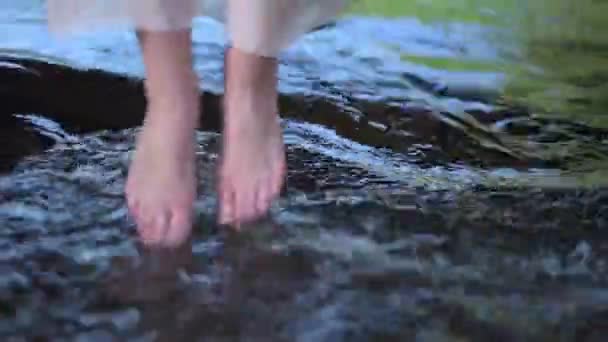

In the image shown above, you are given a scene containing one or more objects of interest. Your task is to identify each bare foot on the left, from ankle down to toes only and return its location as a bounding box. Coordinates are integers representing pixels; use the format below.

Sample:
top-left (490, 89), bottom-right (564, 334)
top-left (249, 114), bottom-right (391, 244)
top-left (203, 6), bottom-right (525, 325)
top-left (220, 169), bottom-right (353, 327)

top-left (126, 111), bottom-right (196, 247)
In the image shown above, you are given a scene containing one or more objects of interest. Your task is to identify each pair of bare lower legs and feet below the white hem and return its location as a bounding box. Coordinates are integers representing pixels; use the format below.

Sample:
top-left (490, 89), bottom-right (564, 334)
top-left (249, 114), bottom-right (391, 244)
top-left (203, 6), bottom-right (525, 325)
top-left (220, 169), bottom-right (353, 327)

top-left (125, 31), bottom-right (286, 247)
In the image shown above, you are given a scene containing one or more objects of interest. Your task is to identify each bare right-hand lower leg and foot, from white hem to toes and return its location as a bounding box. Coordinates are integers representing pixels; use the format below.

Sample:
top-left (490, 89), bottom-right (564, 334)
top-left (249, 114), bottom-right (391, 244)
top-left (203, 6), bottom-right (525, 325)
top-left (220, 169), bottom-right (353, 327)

top-left (219, 48), bottom-right (286, 225)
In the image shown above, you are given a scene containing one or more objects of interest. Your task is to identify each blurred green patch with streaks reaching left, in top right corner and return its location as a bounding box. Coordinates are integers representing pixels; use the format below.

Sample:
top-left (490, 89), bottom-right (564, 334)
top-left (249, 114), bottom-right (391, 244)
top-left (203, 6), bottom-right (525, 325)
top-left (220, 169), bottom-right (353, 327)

top-left (349, 0), bottom-right (608, 128)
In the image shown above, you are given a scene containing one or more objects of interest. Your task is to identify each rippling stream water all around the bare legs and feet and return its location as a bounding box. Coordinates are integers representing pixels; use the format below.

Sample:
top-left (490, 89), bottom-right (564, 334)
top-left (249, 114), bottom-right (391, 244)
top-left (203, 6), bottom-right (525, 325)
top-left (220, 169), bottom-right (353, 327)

top-left (0, 0), bottom-right (608, 342)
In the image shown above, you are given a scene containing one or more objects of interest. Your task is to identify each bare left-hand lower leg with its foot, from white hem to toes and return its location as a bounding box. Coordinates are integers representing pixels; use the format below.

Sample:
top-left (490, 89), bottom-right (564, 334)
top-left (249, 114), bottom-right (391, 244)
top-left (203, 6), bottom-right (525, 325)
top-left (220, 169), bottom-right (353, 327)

top-left (126, 30), bottom-right (200, 247)
